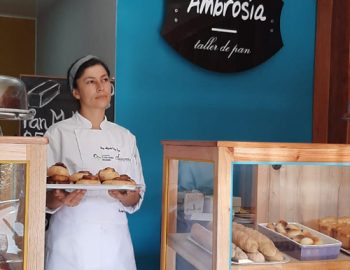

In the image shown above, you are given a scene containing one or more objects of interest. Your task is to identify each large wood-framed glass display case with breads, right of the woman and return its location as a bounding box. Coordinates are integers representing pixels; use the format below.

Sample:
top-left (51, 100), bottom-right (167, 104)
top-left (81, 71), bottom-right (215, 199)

top-left (161, 141), bottom-right (350, 270)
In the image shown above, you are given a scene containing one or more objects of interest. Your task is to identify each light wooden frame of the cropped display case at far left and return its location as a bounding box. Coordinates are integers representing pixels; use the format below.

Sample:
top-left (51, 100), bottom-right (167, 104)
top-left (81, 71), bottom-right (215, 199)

top-left (0, 136), bottom-right (48, 270)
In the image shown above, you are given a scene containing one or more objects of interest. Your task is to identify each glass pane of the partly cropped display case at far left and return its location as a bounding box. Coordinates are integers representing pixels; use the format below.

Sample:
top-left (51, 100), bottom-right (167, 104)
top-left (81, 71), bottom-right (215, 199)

top-left (0, 162), bottom-right (26, 270)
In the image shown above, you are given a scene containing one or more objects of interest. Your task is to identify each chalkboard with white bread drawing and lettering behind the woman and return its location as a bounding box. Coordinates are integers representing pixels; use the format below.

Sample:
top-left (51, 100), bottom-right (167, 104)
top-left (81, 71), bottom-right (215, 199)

top-left (21, 75), bottom-right (114, 136)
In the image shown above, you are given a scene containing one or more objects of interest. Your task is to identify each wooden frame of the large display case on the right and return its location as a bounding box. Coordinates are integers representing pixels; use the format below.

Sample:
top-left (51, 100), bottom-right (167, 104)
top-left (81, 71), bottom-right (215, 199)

top-left (161, 141), bottom-right (350, 270)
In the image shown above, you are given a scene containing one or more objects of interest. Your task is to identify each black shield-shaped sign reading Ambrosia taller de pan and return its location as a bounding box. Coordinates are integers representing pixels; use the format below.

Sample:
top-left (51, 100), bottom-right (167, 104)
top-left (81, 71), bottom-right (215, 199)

top-left (162, 0), bottom-right (283, 72)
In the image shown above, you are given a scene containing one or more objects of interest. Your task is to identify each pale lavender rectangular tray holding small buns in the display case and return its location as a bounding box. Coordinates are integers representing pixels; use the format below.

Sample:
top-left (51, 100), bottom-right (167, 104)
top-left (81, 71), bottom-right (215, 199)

top-left (258, 222), bottom-right (341, 261)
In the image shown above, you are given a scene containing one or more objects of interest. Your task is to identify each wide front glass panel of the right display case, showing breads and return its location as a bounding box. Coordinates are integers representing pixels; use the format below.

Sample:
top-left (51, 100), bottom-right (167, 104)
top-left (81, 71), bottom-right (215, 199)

top-left (232, 163), bottom-right (350, 264)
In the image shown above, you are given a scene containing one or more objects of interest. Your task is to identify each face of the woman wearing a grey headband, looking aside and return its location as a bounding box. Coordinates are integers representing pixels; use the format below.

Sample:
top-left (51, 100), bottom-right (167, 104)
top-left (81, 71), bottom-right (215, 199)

top-left (73, 65), bottom-right (112, 109)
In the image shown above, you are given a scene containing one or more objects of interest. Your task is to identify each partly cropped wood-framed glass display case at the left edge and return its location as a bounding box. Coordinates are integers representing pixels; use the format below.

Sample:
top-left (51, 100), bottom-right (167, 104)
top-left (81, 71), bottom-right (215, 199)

top-left (0, 136), bottom-right (47, 270)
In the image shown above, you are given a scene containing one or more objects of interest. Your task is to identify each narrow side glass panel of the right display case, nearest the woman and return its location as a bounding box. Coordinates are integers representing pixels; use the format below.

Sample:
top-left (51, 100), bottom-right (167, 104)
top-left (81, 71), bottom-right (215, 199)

top-left (167, 160), bottom-right (214, 270)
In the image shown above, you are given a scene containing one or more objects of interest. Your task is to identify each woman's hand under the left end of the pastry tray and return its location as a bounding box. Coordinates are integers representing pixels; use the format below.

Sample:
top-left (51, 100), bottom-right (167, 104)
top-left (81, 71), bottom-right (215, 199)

top-left (47, 189), bottom-right (86, 209)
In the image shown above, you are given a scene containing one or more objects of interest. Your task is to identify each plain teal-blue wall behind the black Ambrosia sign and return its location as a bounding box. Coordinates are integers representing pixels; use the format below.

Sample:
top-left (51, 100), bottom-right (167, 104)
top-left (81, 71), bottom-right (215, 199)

top-left (116, 0), bottom-right (316, 270)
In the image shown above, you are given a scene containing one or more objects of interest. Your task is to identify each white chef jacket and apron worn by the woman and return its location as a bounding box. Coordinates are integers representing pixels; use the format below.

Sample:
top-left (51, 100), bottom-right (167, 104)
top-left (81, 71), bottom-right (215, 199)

top-left (45, 113), bottom-right (145, 270)
